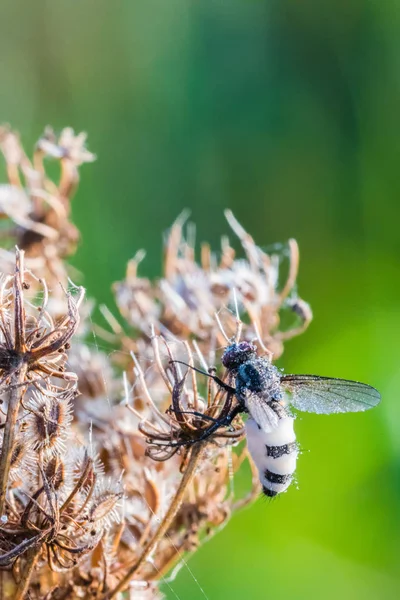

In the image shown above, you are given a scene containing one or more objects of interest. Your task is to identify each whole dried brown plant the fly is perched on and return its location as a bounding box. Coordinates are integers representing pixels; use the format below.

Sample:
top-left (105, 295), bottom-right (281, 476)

top-left (0, 127), bottom-right (311, 600)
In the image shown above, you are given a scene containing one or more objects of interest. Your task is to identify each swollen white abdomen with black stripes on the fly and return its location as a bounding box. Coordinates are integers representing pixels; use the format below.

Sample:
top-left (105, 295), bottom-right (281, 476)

top-left (246, 414), bottom-right (298, 497)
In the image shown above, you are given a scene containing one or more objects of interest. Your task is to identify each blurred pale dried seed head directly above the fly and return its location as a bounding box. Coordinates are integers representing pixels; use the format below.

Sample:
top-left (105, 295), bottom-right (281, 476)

top-left (114, 211), bottom-right (312, 358)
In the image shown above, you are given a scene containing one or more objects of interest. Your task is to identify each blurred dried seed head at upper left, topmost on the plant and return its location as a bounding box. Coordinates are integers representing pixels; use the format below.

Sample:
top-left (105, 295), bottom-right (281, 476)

top-left (0, 127), bottom-right (95, 289)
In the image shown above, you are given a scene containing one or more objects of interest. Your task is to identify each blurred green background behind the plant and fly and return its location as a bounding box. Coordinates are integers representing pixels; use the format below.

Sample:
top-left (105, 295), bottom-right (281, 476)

top-left (0, 0), bottom-right (400, 600)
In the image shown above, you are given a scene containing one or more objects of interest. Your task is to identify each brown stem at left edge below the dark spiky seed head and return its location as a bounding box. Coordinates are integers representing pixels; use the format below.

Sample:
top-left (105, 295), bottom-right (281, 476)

top-left (0, 365), bottom-right (27, 516)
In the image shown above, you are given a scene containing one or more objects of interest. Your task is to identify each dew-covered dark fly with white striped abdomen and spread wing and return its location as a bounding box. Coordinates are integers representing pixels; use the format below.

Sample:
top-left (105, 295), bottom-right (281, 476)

top-left (170, 341), bottom-right (381, 497)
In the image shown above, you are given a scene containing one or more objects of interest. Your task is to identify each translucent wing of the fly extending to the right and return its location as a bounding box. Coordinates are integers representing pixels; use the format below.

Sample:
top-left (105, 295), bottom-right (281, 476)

top-left (281, 375), bottom-right (381, 414)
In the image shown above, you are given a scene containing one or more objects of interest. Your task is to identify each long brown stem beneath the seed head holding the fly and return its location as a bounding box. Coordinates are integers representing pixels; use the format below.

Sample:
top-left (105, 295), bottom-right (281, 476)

top-left (103, 443), bottom-right (206, 600)
